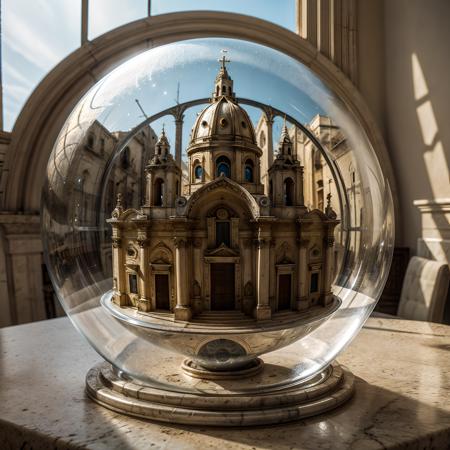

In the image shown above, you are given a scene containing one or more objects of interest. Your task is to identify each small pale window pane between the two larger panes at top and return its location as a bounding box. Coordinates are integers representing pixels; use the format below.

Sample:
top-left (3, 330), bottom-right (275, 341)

top-left (89, 0), bottom-right (148, 39)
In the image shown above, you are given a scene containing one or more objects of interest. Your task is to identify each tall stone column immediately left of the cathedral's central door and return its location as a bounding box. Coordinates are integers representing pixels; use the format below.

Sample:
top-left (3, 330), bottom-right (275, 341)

top-left (174, 237), bottom-right (192, 321)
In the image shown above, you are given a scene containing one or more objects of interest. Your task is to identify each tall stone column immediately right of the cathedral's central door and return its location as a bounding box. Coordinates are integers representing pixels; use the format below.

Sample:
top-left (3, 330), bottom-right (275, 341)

top-left (254, 226), bottom-right (272, 320)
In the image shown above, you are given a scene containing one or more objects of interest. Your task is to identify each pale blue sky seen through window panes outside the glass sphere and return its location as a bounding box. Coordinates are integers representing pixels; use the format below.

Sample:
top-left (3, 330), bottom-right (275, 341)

top-left (0, 0), bottom-right (295, 131)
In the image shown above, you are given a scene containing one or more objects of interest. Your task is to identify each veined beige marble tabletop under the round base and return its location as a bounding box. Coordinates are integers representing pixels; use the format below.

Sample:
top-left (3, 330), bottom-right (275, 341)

top-left (0, 318), bottom-right (450, 450)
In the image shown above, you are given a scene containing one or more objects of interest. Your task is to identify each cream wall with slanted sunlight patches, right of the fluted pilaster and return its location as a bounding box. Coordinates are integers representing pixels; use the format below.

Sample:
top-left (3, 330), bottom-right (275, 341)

top-left (385, 0), bottom-right (450, 249)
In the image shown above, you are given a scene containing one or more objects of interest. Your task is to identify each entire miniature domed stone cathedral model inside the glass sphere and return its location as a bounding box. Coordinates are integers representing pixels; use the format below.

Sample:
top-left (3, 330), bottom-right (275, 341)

top-left (108, 58), bottom-right (339, 321)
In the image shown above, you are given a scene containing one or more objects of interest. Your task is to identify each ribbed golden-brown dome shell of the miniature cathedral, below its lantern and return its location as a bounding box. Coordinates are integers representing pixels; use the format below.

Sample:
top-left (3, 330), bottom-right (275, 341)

top-left (191, 96), bottom-right (256, 145)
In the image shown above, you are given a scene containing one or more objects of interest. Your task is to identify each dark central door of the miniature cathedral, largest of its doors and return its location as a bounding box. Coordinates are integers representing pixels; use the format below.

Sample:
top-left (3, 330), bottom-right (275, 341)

top-left (211, 263), bottom-right (235, 311)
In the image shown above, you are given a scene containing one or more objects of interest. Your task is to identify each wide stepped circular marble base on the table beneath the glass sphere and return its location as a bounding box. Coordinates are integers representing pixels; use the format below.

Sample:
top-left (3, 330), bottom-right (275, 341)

top-left (86, 363), bottom-right (353, 427)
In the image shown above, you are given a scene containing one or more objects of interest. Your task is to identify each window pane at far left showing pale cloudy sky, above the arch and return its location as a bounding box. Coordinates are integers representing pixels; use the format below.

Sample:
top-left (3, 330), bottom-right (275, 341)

top-left (1, 0), bottom-right (81, 131)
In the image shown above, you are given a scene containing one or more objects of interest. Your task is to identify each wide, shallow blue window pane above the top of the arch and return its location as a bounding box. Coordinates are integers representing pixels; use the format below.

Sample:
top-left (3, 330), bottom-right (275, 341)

top-left (152, 0), bottom-right (296, 31)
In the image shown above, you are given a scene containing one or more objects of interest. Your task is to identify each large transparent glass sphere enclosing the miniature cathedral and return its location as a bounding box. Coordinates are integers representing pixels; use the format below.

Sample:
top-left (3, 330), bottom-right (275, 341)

top-left (42, 38), bottom-right (394, 389)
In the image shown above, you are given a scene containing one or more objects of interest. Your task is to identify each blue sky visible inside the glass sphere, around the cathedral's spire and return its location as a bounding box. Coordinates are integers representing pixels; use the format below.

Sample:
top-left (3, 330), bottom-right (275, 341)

top-left (62, 38), bottom-right (330, 159)
